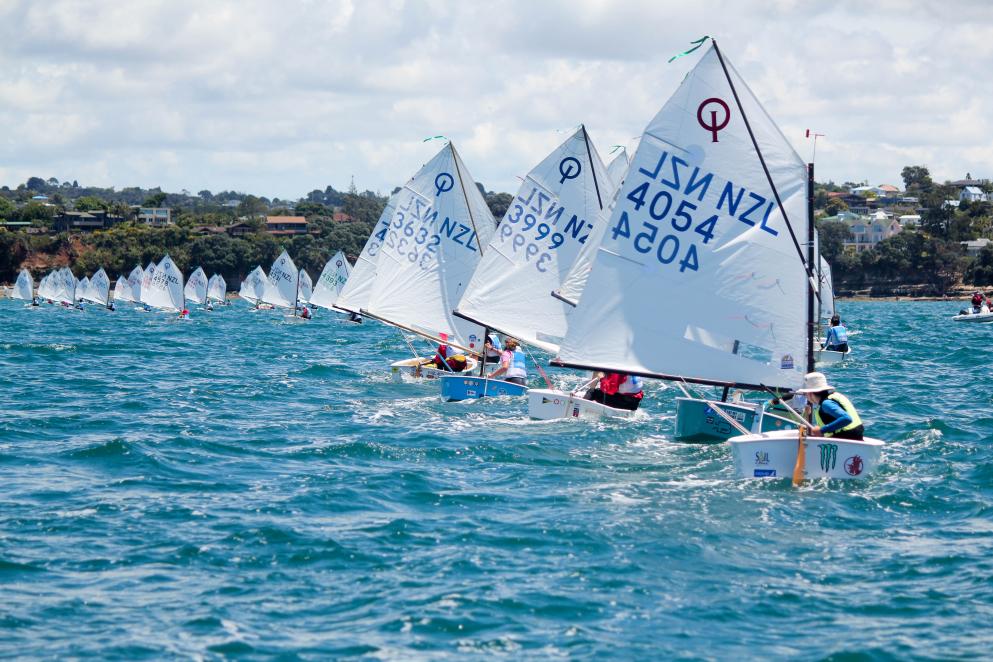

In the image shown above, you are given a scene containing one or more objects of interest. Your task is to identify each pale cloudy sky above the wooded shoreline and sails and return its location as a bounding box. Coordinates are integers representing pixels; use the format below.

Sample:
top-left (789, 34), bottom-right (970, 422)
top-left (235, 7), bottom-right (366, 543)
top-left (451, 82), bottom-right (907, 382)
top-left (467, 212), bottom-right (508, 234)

top-left (0, 0), bottom-right (993, 199)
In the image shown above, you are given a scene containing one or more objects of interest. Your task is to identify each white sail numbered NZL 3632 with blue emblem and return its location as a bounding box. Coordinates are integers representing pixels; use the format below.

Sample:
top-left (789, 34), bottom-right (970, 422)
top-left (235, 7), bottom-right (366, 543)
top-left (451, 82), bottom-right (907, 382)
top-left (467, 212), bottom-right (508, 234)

top-left (367, 144), bottom-right (496, 351)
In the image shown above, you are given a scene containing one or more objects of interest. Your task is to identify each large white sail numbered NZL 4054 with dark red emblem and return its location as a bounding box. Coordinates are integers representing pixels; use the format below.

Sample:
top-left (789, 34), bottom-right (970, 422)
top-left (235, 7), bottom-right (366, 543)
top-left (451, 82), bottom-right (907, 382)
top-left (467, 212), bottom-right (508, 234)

top-left (559, 45), bottom-right (809, 388)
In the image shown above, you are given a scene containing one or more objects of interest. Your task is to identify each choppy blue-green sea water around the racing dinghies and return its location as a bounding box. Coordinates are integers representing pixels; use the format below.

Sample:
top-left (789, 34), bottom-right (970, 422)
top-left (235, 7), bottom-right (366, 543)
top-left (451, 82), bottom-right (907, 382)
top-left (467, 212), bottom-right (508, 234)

top-left (0, 300), bottom-right (993, 660)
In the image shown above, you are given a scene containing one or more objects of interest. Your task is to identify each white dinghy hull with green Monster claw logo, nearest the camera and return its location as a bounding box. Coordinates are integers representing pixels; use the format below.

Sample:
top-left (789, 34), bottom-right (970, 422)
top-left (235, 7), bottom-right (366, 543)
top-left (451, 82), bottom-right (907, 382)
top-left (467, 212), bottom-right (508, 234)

top-left (728, 430), bottom-right (883, 480)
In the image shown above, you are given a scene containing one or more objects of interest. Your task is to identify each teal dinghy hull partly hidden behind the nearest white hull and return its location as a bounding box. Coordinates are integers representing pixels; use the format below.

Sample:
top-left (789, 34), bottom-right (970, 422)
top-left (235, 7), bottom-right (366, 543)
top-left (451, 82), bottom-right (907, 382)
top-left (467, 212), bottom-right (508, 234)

top-left (675, 398), bottom-right (796, 444)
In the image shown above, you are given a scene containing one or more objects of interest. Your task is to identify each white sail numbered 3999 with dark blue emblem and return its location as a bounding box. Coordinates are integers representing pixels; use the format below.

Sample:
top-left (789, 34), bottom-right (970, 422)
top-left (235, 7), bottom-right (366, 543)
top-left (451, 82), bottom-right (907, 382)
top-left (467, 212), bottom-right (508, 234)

top-left (457, 127), bottom-right (613, 352)
